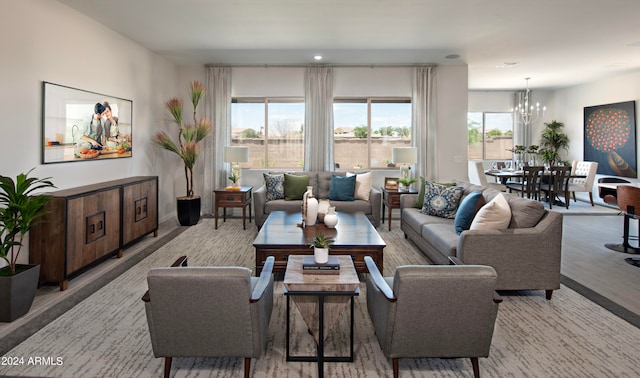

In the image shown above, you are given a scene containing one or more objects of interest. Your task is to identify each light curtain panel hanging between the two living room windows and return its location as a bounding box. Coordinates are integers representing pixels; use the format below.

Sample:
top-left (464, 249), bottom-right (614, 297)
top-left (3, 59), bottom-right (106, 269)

top-left (304, 66), bottom-right (334, 171)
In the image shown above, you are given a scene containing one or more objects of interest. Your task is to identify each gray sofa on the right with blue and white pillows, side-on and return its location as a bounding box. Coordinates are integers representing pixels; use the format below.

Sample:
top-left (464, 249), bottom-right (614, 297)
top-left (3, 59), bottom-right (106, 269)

top-left (400, 182), bottom-right (562, 299)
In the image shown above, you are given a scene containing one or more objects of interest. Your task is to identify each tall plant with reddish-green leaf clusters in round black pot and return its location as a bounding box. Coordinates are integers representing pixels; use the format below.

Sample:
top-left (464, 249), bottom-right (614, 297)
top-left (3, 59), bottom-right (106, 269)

top-left (154, 81), bottom-right (211, 226)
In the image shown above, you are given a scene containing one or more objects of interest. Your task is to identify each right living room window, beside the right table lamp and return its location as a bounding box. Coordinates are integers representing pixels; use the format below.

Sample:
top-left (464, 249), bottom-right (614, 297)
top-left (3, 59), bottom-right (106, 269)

top-left (333, 98), bottom-right (411, 169)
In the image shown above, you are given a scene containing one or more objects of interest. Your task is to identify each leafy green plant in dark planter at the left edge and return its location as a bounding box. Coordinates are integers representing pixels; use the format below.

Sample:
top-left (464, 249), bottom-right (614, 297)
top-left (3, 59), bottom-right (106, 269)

top-left (0, 169), bottom-right (54, 322)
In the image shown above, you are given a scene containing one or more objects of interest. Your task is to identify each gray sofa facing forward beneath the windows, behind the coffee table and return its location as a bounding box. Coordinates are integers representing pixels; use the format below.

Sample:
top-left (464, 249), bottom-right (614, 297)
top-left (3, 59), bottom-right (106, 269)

top-left (253, 172), bottom-right (382, 227)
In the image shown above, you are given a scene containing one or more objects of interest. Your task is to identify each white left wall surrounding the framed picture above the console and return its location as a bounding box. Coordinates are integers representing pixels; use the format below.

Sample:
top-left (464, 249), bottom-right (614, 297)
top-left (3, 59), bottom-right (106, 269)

top-left (0, 0), bottom-right (184, 261)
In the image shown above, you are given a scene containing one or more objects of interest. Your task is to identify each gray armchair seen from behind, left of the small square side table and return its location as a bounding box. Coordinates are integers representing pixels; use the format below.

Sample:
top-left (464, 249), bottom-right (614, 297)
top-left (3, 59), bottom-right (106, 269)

top-left (142, 257), bottom-right (274, 377)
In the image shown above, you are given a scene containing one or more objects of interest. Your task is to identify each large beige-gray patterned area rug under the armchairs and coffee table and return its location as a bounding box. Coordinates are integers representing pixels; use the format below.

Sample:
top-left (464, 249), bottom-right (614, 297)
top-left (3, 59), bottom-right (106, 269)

top-left (0, 219), bottom-right (640, 377)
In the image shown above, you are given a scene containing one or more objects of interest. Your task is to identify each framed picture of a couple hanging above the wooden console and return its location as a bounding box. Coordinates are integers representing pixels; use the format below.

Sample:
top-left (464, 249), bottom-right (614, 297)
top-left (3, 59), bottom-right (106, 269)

top-left (42, 81), bottom-right (133, 164)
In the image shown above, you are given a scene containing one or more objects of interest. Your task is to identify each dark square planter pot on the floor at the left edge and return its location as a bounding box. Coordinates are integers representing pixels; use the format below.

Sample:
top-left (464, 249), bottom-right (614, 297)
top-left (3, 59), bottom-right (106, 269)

top-left (0, 265), bottom-right (40, 322)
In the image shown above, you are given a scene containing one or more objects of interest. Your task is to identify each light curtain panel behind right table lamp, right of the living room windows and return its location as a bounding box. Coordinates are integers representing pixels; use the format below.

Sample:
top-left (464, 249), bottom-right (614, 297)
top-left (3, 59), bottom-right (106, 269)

top-left (411, 66), bottom-right (438, 181)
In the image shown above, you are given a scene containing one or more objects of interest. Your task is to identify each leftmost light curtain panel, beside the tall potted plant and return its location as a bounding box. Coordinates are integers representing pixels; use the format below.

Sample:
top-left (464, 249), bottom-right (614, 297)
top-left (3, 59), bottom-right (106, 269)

top-left (201, 66), bottom-right (231, 215)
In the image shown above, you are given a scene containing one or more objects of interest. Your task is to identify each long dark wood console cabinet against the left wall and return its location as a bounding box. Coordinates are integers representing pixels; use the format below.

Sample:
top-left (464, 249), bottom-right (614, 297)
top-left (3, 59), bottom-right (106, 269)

top-left (29, 176), bottom-right (158, 290)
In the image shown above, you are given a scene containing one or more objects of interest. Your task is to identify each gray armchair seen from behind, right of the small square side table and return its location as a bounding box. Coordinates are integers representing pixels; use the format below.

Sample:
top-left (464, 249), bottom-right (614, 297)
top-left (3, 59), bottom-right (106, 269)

top-left (365, 257), bottom-right (502, 377)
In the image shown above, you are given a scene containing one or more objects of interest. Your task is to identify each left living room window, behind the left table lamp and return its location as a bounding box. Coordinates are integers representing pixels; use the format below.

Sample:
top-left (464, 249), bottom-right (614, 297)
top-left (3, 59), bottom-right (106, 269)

top-left (231, 98), bottom-right (304, 168)
